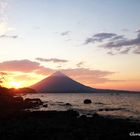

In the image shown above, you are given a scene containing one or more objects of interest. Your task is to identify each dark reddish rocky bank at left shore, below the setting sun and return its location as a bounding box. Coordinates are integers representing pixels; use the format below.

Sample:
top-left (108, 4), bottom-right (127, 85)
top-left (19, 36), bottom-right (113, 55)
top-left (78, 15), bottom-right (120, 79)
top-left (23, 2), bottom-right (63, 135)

top-left (0, 88), bottom-right (43, 112)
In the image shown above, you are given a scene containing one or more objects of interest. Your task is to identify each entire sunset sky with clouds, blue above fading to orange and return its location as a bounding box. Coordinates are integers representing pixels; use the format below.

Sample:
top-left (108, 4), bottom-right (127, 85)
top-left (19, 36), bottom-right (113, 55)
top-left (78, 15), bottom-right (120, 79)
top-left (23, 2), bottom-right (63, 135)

top-left (0, 0), bottom-right (140, 91)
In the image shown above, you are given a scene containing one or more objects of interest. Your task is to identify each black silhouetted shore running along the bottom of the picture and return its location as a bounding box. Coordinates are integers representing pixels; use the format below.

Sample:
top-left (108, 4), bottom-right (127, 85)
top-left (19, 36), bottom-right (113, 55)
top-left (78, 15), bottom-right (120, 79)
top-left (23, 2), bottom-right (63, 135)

top-left (0, 110), bottom-right (140, 140)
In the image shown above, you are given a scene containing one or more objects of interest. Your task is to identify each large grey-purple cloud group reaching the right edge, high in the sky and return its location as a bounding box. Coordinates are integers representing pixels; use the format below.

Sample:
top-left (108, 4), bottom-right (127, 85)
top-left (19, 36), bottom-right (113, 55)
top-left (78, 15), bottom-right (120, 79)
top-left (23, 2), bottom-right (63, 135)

top-left (85, 30), bottom-right (140, 55)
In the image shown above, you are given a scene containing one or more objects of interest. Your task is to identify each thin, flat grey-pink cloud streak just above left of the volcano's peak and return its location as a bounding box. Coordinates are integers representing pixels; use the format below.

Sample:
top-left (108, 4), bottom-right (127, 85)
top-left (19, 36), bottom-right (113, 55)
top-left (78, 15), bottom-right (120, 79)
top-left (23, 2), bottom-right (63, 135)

top-left (36, 57), bottom-right (68, 63)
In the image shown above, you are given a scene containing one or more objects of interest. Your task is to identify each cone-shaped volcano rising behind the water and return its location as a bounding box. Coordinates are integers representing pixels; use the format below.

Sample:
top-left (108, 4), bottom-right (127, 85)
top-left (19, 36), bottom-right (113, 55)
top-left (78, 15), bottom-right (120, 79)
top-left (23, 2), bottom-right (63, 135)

top-left (31, 72), bottom-right (96, 93)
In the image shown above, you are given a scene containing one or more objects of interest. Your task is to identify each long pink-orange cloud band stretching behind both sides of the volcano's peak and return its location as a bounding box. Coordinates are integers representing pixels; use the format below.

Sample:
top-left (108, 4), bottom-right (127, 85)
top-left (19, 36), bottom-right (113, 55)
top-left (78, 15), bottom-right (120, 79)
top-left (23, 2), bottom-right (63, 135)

top-left (0, 59), bottom-right (115, 85)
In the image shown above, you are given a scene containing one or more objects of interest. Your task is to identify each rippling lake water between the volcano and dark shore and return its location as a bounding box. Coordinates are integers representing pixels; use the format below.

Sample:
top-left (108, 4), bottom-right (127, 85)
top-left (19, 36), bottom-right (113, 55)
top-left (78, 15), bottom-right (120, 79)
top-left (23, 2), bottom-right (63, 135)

top-left (23, 93), bottom-right (140, 120)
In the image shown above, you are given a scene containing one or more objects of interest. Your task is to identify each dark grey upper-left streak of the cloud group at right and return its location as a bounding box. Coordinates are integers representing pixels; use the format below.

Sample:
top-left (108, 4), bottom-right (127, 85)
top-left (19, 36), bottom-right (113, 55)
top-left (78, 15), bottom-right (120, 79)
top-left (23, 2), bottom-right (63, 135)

top-left (84, 33), bottom-right (117, 44)
